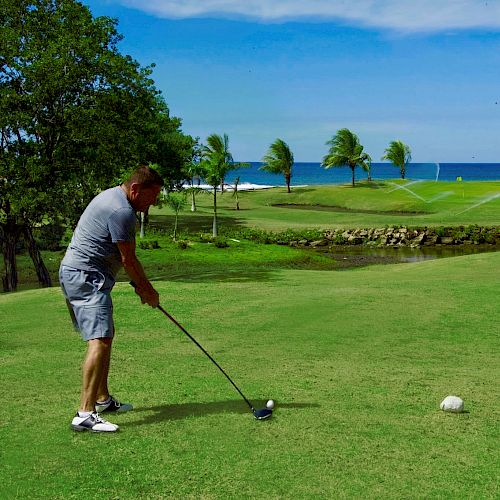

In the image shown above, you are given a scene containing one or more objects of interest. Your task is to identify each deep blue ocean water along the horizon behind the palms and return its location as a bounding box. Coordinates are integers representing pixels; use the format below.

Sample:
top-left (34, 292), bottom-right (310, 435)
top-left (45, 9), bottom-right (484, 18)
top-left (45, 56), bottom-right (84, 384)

top-left (226, 162), bottom-right (500, 186)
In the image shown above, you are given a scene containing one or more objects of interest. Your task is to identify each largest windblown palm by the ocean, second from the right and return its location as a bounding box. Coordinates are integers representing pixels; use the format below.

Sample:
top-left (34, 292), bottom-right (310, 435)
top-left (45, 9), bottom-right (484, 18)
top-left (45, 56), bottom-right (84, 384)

top-left (322, 128), bottom-right (372, 187)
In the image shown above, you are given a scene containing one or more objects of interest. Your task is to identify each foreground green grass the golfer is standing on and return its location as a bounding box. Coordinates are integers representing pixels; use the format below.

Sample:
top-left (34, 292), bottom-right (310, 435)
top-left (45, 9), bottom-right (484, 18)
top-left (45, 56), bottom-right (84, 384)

top-left (0, 249), bottom-right (500, 498)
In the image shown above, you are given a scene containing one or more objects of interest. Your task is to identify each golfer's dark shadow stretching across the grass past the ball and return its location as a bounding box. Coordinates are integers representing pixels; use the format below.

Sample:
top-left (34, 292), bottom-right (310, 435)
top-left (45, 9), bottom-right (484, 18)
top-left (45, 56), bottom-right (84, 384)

top-left (120, 400), bottom-right (320, 427)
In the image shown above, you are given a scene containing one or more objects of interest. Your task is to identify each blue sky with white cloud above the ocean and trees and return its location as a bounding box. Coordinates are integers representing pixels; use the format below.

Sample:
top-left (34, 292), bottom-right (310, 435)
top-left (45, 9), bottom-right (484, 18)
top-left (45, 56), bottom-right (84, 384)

top-left (81, 0), bottom-right (500, 163)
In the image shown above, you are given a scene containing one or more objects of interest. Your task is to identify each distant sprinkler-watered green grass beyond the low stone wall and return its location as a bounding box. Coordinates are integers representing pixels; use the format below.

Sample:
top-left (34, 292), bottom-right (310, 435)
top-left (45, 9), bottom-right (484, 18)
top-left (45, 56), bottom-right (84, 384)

top-left (157, 180), bottom-right (500, 231)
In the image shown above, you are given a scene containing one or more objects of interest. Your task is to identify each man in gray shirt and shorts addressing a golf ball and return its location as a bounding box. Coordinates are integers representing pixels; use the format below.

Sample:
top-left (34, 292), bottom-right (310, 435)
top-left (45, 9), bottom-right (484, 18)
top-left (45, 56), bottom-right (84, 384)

top-left (59, 166), bottom-right (163, 432)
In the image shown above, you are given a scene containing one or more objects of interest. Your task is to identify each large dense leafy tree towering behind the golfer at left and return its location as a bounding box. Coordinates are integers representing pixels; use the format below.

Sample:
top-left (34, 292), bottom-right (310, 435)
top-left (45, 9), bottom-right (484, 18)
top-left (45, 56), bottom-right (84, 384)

top-left (0, 0), bottom-right (188, 291)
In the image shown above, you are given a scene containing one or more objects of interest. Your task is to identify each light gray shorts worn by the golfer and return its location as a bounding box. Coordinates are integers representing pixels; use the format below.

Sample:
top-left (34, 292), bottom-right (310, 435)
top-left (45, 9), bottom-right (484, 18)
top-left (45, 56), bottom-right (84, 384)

top-left (59, 266), bottom-right (115, 341)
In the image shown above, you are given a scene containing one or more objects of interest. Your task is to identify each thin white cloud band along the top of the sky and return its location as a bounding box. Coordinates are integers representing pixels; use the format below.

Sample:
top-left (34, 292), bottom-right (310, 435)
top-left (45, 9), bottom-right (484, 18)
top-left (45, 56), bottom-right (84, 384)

top-left (118, 0), bottom-right (500, 32)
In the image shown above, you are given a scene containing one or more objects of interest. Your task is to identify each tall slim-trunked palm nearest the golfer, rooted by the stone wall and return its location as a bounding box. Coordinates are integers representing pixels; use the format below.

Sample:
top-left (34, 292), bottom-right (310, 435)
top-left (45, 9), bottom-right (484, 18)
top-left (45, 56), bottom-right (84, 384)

top-left (202, 134), bottom-right (234, 238)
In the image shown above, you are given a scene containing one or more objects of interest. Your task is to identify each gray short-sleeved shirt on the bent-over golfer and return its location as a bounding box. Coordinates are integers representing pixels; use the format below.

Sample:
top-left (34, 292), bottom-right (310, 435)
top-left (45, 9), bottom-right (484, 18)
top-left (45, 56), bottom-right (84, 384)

top-left (61, 186), bottom-right (137, 279)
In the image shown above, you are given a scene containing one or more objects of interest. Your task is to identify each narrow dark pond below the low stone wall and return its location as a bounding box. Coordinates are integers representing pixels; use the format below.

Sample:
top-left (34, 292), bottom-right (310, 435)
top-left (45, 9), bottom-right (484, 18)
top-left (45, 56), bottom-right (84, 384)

top-left (314, 245), bottom-right (500, 269)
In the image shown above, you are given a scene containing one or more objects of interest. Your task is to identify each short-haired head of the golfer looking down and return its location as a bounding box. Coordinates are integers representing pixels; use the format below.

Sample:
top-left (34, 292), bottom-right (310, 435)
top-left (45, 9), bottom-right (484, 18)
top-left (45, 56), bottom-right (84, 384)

top-left (123, 165), bottom-right (164, 212)
